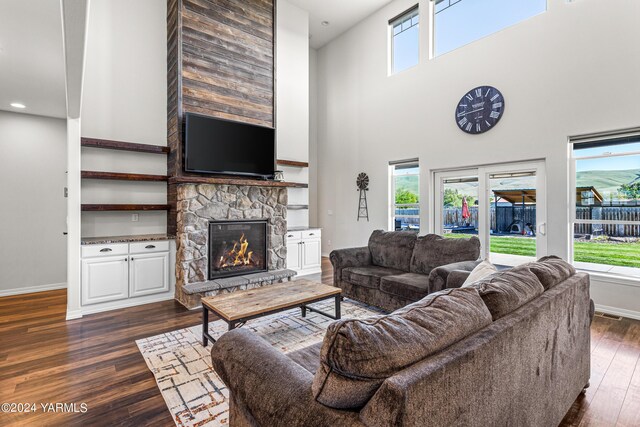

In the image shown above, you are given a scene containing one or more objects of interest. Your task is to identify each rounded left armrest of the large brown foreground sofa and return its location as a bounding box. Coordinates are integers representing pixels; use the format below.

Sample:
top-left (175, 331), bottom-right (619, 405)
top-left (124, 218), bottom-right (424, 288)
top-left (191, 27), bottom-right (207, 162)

top-left (211, 329), bottom-right (362, 427)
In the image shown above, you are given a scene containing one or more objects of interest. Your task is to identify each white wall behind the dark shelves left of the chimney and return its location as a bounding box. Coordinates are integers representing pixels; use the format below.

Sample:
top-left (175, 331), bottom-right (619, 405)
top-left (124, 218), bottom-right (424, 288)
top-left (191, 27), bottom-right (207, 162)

top-left (81, 0), bottom-right (167, 237)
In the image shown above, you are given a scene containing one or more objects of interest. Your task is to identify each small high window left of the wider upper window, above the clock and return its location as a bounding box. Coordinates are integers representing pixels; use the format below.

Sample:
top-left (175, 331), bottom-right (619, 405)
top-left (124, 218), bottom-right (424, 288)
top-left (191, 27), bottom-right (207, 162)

top-left (389, 6), bottom-right (420, 74)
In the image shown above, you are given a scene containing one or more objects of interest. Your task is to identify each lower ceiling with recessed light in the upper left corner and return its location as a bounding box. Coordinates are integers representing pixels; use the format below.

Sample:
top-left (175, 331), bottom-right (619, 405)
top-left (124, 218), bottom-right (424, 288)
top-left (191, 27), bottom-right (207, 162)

top-left (0, 0), bottom-right (67, 118)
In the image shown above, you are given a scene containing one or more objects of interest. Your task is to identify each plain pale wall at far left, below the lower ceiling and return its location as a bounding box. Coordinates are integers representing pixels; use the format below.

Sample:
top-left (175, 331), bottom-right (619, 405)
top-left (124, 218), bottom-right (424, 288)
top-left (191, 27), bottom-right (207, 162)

top-left (0, 111), bottom-right (67, 296)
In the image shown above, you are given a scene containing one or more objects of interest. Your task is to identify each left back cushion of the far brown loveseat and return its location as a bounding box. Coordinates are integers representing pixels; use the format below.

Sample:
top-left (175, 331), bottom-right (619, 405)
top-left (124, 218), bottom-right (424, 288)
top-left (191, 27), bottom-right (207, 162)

top-left (369, 230), bottom-right (417, 271)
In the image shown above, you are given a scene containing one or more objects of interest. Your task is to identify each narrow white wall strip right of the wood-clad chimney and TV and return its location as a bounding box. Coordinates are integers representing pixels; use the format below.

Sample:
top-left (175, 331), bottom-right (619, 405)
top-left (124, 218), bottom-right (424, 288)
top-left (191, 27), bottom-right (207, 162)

top-left (276, 0), bottom-right (309, 227)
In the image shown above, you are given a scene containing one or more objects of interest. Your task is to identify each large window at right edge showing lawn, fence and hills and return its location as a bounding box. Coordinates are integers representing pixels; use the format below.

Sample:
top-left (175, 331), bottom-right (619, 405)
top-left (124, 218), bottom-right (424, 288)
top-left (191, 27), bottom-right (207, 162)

top-left (572, 135), bottom-right (640, 276)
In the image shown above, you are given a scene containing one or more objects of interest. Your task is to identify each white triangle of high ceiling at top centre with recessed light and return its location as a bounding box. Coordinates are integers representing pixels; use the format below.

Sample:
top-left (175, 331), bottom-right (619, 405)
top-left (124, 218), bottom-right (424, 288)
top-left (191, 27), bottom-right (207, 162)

top-left (289, 0), bottom-right (392, 49)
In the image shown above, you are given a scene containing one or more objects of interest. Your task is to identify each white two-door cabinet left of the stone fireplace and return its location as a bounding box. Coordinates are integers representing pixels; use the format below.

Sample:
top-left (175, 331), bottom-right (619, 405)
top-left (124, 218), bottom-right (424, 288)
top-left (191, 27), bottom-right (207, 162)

top-left (81, 241), bottom-right (171, 306)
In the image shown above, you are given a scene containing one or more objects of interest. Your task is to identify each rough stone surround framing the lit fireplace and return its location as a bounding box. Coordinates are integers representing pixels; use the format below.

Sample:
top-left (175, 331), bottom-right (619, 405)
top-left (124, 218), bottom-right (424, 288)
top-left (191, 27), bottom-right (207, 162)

top-left (176, 184), bottom-right (287, 308)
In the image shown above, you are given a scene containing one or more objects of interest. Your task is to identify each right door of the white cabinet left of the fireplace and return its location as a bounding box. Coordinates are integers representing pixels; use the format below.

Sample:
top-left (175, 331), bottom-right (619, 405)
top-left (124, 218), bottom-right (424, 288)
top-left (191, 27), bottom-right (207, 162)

top-left (129, 252), bottom-right (169, 297)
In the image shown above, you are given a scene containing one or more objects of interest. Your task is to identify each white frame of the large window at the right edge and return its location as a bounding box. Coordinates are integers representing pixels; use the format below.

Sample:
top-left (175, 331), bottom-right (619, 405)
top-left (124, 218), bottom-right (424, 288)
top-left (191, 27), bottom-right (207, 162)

top-left (568, 128), bottom-right (640, 280)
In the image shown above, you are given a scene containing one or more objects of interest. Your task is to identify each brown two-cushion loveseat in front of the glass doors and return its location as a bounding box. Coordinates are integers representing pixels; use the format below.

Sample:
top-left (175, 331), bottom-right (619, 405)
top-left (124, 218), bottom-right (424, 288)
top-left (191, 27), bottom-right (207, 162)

top-left (329, 230), bottom-right (480, 311)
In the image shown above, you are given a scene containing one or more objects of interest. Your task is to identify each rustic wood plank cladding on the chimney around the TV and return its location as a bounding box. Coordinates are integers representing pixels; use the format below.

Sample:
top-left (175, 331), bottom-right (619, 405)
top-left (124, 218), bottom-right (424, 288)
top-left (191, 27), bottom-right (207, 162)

top-left (167, 0), bottom-right (276, 234)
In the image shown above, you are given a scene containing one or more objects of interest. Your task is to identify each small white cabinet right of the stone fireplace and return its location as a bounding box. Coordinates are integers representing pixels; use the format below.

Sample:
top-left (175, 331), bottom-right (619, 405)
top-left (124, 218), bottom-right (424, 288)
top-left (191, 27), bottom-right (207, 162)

top-left (286, 229), bottom-right (322, 276)
